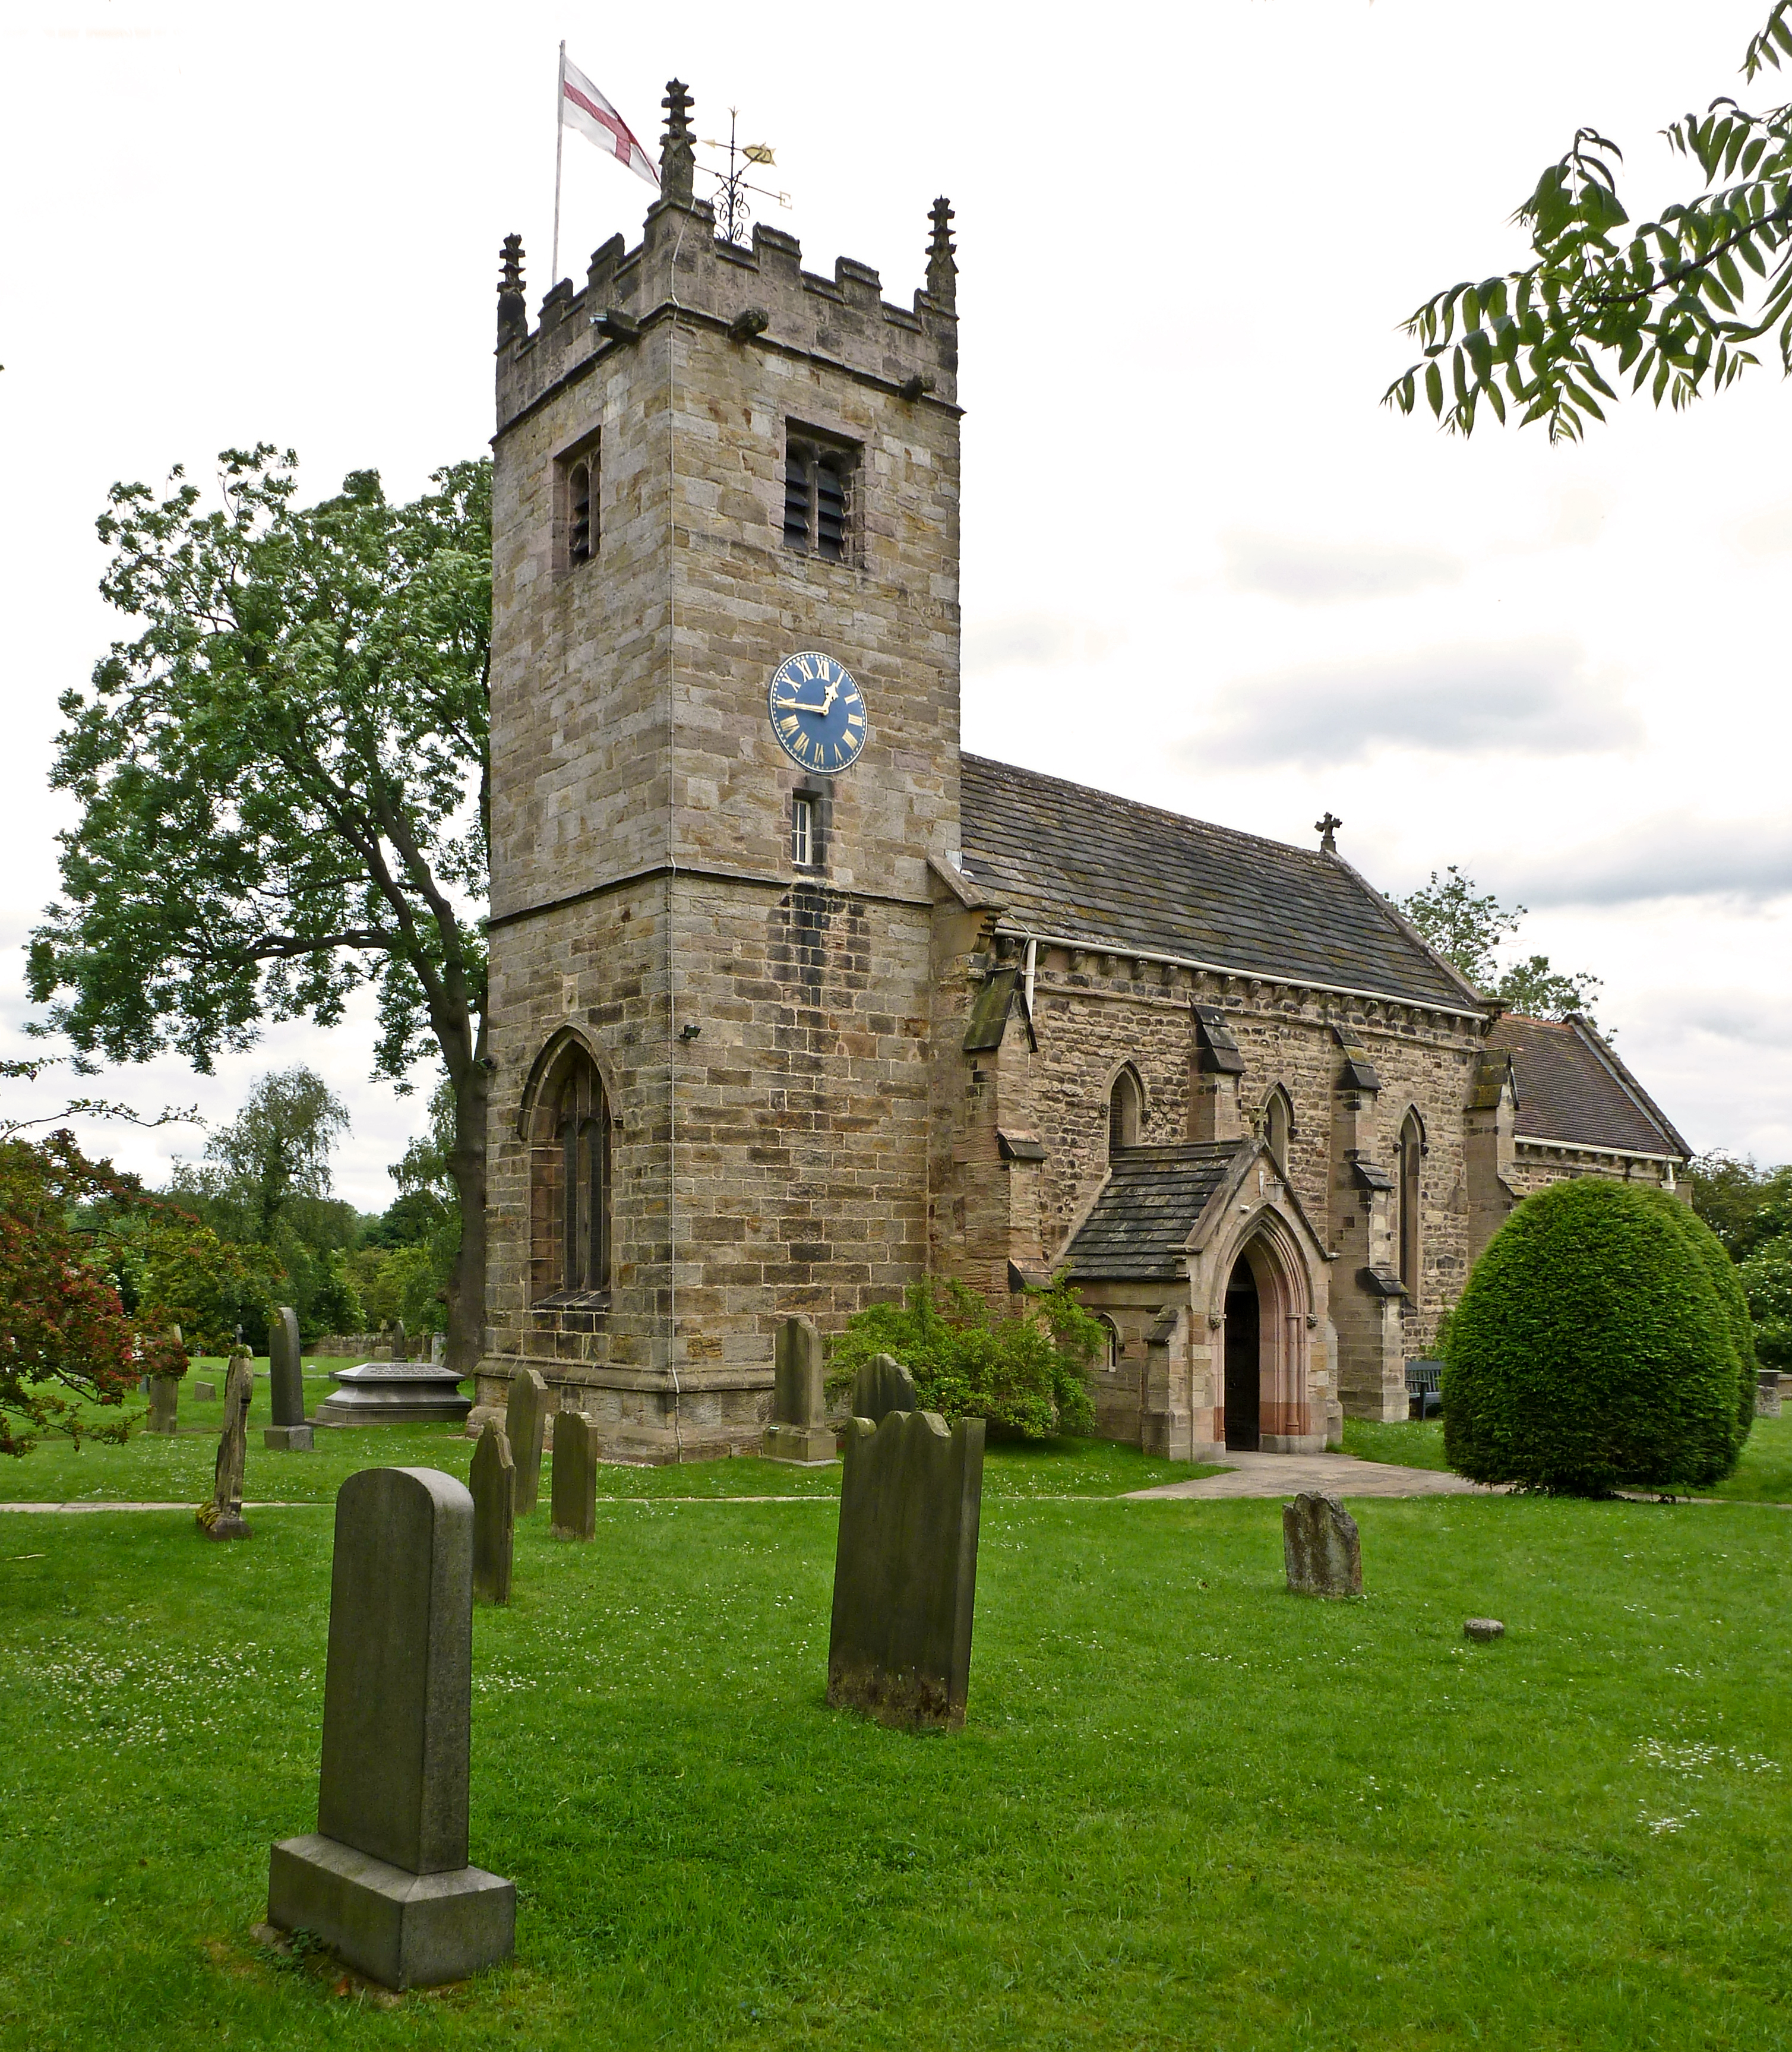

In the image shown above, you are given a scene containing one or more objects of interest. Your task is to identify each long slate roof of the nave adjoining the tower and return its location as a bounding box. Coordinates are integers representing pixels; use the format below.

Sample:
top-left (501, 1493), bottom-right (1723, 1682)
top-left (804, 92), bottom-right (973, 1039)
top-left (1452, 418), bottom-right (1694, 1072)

top-left (960, 755), bottom-right (1472, 1009)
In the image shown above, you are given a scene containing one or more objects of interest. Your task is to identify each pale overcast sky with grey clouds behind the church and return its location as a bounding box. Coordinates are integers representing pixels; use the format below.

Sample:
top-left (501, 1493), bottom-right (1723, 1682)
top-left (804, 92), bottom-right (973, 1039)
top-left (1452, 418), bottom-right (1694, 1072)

top-left (0, 0), bottom-right (1792, 1208)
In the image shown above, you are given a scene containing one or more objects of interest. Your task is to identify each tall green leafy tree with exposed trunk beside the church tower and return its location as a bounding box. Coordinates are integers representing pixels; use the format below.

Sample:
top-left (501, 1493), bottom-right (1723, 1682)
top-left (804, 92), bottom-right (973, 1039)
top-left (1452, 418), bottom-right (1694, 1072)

top-left (29, 457), bottom-right (491, 1371)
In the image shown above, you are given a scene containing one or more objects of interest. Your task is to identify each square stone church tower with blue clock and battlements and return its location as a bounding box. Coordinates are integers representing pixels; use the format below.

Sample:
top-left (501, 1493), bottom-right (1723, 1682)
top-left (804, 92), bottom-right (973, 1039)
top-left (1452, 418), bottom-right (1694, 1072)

top-left (481, 82), bottom-right (959, 1459)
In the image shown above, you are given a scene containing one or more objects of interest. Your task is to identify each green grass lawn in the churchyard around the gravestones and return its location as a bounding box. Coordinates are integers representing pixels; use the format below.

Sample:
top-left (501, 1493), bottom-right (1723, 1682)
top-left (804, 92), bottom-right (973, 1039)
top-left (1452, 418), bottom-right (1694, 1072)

top-left (0, 1426), bottom-right (1792, 2052)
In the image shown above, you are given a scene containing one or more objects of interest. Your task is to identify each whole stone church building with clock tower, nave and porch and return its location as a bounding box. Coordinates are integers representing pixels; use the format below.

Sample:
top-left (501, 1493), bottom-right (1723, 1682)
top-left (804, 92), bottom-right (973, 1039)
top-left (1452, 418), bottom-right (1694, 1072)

top-left (478, 82), bottom-right (1689, 1461)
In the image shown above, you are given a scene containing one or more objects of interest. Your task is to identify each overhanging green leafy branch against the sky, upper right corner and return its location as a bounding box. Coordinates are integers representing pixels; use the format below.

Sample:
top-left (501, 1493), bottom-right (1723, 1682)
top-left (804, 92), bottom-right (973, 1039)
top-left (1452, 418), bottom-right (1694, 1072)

top-left (1386, 0), bottom-right (1792, 441)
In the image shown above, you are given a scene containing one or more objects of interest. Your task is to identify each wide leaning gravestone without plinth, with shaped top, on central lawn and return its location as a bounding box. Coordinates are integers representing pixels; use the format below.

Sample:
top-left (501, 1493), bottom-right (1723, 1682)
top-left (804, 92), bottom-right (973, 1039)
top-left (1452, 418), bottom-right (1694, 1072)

top-left (827, 1410), bottom-right (983, 1730)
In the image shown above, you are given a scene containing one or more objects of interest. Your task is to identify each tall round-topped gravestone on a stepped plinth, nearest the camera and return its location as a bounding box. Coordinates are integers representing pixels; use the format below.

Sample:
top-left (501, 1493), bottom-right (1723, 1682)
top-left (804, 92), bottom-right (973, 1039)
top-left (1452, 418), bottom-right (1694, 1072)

top-left (267, 1467), bottom-right (517, 1988)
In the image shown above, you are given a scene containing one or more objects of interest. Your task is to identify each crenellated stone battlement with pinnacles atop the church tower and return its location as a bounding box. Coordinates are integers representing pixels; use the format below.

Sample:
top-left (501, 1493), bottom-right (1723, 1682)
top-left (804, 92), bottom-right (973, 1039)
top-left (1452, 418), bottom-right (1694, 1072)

top-left (497, 86), bottom-right (959, 433)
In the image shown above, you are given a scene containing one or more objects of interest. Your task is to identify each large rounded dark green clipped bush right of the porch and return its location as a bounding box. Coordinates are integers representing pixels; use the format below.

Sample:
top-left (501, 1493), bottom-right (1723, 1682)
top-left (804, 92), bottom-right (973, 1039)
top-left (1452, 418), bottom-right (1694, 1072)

top-left (1441, 1176), bottom-right (1755, 1496)
